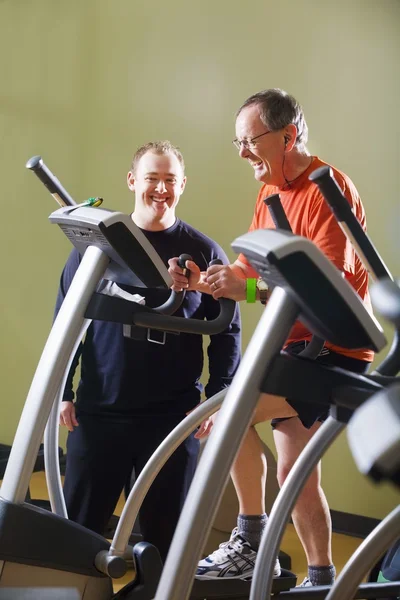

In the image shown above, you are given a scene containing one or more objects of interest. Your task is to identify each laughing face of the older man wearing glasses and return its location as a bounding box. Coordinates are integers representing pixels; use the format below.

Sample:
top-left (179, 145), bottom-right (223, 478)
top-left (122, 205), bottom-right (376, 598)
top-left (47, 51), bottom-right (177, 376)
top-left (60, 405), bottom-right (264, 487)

top-left (236, 104), bottom-right (285, 186)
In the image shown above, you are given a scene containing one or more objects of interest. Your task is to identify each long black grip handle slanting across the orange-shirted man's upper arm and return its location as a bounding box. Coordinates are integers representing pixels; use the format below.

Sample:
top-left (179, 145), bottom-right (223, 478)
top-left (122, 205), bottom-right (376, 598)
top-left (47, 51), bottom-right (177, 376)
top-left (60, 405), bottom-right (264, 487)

top-left (309, 165), bottom-right (393, 279)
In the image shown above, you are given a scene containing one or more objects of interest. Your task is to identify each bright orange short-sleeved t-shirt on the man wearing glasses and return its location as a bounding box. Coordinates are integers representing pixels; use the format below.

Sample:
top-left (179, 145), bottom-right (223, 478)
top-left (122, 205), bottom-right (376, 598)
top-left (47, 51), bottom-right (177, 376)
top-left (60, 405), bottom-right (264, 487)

top-left (238, 157), bottom-right (374, 362)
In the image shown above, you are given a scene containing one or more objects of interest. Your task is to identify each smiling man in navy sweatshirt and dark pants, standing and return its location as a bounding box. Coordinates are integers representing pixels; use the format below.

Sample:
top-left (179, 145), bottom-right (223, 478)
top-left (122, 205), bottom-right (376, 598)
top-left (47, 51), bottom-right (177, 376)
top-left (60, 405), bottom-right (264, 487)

top-left (56, 142), bottom-right (240, 559)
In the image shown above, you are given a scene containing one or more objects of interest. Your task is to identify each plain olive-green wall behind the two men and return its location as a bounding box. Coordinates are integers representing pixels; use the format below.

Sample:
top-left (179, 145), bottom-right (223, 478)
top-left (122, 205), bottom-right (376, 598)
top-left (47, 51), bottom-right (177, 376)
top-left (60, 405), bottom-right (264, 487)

top-left (0, 0), bottom-right (400, 518)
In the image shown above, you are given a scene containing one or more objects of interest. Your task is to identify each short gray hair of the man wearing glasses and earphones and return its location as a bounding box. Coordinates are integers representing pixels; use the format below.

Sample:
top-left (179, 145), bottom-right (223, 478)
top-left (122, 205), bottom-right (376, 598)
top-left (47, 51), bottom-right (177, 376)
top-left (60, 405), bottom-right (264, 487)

top-left (236, 88), bottom-right (308, 149)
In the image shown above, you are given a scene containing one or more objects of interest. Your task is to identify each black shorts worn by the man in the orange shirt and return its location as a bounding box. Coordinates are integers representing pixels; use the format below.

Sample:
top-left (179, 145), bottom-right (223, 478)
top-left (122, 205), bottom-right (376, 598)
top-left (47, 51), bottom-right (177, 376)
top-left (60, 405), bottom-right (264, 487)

top-left (271, 341), bottom-right (371, 429)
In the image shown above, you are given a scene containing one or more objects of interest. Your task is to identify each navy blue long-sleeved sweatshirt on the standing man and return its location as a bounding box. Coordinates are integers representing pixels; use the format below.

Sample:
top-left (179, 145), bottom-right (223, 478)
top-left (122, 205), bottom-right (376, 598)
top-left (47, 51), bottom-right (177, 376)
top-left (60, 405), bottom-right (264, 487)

top-left (56, 219), bottom-right (241, 420)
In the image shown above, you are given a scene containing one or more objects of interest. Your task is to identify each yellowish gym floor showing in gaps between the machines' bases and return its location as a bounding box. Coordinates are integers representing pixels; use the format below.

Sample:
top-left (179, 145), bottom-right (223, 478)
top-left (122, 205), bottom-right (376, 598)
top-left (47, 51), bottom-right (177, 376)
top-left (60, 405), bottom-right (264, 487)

top-left (25, 472), bottom-right (362, 591)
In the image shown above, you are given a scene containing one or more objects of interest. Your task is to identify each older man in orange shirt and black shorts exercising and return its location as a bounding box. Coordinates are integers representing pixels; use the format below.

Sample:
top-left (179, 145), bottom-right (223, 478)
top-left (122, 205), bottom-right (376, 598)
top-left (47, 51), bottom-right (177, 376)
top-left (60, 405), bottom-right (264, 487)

top-left (170, 89), bottom-right (373, 587)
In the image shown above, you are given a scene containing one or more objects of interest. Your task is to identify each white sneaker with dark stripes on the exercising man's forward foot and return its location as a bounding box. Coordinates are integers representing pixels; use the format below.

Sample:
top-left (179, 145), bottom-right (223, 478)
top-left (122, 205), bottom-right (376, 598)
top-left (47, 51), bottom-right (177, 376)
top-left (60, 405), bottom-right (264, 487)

top-left (196, 527), bottom-right (281, 579)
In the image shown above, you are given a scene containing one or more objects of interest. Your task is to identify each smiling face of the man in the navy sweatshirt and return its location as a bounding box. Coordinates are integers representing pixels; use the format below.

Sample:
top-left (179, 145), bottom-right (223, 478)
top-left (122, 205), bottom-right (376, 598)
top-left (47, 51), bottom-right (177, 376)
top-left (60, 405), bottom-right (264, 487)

top-left (128, 151), bottom-right (186, 231)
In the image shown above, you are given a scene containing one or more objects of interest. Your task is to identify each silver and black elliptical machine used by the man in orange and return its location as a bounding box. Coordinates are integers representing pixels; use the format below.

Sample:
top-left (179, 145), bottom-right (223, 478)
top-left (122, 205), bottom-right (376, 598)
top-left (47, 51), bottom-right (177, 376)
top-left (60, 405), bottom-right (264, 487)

top-left (152, 165), bottom-right (400, 600)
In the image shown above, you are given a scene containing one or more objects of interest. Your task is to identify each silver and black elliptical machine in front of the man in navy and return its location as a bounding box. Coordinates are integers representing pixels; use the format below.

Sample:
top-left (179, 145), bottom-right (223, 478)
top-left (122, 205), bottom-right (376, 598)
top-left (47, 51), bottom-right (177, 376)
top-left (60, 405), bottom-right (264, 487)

top-left (0, 157), bottom-right (235, 600)
